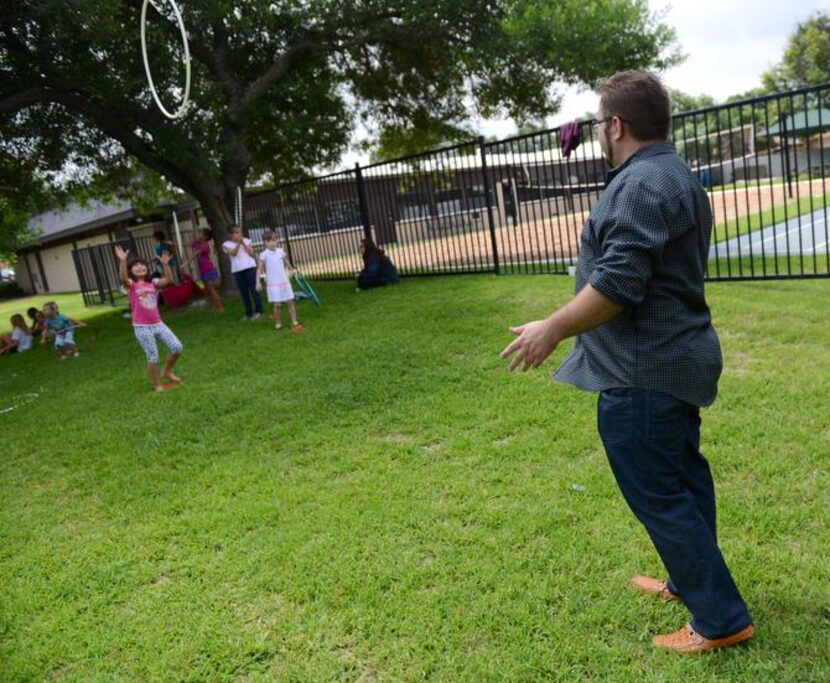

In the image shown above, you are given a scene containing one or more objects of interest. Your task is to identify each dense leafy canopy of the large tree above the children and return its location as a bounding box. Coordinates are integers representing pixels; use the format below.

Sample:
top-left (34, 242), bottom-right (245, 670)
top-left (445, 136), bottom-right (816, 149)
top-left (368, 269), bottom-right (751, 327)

top-left (0, 0), bottom-right (679, 246)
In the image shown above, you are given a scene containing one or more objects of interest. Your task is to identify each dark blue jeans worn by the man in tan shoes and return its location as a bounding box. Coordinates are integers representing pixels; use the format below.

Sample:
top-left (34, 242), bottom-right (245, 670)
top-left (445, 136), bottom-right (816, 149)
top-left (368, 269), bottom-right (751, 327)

top-left (597, 389), bottom-right (752, 638)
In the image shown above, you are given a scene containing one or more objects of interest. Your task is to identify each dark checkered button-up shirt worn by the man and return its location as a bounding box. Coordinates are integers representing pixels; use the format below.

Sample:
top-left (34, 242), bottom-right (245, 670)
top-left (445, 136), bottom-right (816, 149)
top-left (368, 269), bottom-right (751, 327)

top-left (554, 142), bottom-right (722, 406)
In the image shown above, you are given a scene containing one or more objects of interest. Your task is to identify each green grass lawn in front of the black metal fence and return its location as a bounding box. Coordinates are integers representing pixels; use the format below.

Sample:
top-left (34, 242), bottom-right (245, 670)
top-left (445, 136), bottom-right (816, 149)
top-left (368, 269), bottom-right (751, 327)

top-left (0, 276), bottom-right (830, 683)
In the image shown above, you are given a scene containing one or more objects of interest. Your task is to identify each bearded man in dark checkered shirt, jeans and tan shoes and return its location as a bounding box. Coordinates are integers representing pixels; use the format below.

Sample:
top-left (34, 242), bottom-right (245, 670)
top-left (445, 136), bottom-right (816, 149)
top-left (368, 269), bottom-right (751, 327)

top-left (502, 71), bottom-right (754, 654)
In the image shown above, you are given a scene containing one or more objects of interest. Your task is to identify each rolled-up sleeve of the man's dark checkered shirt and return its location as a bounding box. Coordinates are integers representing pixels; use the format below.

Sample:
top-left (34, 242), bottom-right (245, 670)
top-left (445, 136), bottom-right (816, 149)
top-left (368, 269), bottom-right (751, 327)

top-left (589, 182), bottom-right (669, 307)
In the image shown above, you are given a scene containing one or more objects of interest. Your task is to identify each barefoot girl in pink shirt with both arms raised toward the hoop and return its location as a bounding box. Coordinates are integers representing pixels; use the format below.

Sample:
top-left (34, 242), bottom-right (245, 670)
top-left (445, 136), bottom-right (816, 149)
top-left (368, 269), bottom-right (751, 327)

top-left (115, 246), bottom-right (183, 391)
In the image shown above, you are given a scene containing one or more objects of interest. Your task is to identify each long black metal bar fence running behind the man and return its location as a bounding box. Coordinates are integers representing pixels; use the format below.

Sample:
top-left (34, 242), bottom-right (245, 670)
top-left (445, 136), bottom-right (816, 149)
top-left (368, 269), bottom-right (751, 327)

top-left (243, 84), bottom-right (830, 280)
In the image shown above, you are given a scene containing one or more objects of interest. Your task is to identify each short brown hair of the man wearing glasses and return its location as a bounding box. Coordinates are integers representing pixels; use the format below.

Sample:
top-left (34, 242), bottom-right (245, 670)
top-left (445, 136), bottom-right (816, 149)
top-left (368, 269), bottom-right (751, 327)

top-left (597, 71), bottom-right (671, 140)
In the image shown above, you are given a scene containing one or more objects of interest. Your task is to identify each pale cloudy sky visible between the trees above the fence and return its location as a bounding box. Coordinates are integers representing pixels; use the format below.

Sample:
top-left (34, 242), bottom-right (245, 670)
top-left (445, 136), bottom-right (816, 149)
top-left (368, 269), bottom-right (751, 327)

top-left (340, 0), bottom-right (828, 168)
